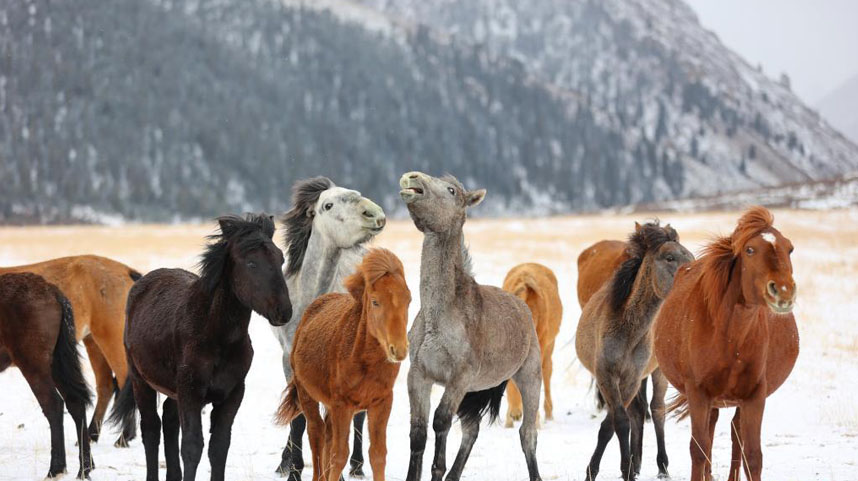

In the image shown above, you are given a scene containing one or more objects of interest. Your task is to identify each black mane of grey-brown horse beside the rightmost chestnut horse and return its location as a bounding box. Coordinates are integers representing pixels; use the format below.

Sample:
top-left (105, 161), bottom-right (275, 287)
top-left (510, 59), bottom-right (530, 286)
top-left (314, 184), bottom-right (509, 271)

top-left (608, 220), bottom-right (679, 312)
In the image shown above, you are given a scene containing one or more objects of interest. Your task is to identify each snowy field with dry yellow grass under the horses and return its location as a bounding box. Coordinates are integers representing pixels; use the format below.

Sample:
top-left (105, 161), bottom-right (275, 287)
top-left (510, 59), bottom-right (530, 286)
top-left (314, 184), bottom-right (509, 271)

top-left (0, 210), bottom-right (858, 481)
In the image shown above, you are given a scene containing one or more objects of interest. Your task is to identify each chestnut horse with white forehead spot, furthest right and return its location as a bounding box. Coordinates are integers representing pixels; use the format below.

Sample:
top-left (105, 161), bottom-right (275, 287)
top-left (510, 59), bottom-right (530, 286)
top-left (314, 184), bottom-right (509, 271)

top-left (655, 207), bottom-right (798, 481)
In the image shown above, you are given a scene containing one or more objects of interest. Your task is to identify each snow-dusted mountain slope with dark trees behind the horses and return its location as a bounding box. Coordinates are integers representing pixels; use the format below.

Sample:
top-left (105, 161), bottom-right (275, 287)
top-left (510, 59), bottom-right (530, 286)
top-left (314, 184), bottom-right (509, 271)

top-left (0, 0), bottom-right (858, 222)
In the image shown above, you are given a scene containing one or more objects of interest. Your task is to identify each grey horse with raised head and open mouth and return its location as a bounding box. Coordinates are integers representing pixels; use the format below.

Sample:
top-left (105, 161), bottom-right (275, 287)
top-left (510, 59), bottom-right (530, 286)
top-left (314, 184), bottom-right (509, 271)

top-left (399, 172), bottom-right (542, 481)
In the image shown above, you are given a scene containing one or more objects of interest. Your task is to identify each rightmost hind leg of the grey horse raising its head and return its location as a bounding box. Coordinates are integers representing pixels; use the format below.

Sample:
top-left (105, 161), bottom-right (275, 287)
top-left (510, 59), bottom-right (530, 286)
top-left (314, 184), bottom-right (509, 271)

top-left (512, 342), bottom-right (542, 481)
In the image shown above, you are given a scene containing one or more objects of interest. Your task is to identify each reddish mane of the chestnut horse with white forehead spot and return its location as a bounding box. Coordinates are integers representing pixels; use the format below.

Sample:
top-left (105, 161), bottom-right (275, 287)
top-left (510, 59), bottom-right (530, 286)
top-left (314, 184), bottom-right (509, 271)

top-left (700, 206), bottom-right (775, 315)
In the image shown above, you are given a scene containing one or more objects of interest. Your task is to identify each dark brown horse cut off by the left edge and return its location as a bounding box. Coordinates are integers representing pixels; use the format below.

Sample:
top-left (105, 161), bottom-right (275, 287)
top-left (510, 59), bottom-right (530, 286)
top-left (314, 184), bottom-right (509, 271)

top-left (0, 273), bottom-right (95, 479)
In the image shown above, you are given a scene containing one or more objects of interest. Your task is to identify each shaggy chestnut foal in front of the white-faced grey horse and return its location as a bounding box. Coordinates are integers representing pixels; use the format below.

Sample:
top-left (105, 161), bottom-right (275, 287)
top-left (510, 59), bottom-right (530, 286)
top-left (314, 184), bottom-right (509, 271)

top-left (277, 249), bottom-right (411, 481)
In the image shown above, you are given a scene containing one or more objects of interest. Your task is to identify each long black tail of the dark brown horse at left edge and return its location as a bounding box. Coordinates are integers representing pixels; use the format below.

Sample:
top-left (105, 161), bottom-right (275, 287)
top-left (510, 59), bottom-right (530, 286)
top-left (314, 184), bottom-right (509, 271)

top-left (51, 291), bottom-right (92, 407)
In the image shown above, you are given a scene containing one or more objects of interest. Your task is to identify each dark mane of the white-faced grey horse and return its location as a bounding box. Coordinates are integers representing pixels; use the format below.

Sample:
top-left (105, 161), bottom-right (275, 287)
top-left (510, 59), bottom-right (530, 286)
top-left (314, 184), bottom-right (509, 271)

top-left (282, 176), bottom-right (335, 277)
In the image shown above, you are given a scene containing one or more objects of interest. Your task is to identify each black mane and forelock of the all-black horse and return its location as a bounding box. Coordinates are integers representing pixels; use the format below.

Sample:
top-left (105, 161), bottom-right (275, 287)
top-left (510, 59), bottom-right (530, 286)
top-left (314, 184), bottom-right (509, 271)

top-left (199, 214), bottom-right (274, 293)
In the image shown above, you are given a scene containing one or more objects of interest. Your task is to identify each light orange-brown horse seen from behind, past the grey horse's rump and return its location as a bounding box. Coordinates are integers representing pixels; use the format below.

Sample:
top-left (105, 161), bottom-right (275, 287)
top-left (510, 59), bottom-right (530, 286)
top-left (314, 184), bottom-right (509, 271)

top-left (503, 263), bottom-right (563, 428)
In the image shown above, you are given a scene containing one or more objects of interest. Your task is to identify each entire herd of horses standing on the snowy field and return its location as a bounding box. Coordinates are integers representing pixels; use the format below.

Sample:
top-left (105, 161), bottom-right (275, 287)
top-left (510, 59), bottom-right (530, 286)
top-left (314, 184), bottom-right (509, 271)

top-left (0, 172), bottom-right (798, 481)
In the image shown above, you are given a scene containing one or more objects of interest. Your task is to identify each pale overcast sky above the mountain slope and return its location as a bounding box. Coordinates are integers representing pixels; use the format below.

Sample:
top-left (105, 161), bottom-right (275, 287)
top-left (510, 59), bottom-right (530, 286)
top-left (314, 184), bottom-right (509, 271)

top-left (686, 0), bottom-right (858, 105)
